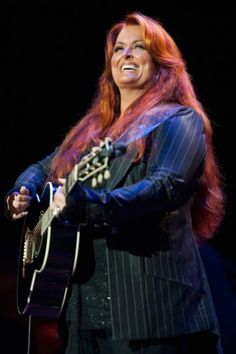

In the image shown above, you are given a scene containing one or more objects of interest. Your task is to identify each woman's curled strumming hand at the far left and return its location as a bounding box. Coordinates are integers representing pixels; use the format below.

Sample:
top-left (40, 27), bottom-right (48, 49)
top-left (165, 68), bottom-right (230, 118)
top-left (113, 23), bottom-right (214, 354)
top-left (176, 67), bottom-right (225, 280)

top-left (7, 186), bottom-right (32, 220)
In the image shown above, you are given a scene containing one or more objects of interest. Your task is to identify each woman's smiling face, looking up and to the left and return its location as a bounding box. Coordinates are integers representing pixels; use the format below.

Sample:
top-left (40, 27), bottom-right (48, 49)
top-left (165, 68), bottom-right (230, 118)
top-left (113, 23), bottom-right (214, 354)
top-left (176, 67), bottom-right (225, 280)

top-left (111, 25), bottom-right (155, 90)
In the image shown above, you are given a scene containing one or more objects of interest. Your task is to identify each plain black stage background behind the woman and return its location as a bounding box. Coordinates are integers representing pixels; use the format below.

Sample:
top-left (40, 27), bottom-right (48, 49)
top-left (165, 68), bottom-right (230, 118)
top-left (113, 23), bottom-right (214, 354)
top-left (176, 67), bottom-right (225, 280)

top-left (0, 0), bottom-right (236, 354)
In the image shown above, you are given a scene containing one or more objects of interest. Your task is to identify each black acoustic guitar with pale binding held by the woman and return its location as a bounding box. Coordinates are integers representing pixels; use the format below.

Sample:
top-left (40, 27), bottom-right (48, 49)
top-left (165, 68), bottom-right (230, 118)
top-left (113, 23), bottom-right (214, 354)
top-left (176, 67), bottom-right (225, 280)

top-left (17, 138), bottom-right (125, 318)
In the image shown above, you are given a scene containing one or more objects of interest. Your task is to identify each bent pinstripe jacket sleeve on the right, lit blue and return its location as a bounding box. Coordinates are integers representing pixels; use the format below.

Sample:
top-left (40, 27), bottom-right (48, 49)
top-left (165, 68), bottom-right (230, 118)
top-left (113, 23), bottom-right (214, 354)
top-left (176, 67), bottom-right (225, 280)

top-left (64, 108), bottom-right (206, 225)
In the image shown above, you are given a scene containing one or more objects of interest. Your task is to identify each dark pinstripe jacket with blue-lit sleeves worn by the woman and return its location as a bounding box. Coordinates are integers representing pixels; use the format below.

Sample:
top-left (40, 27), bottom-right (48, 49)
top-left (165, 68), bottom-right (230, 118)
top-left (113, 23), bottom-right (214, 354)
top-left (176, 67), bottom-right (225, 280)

top-left (6, 106), bottom-right (221, 348)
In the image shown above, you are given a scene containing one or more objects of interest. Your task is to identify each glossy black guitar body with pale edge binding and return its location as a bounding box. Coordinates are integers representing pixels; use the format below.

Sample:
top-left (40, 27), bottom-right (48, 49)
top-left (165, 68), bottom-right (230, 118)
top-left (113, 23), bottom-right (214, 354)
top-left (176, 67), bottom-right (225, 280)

top-left (17, 183), bottom-right (80, 318)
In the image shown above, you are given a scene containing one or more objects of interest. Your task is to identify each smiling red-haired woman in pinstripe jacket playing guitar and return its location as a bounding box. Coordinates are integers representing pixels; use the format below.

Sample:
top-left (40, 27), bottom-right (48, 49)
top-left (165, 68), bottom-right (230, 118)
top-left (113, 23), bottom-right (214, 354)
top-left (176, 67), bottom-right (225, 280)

top-left (7, 12), bottom-right (224, 354)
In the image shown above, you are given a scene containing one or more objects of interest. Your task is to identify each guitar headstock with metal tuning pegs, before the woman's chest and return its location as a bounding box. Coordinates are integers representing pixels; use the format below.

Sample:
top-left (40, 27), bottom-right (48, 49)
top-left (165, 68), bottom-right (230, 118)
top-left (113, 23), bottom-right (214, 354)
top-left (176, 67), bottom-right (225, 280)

top-left (67, 137), bottom-right (126, 193)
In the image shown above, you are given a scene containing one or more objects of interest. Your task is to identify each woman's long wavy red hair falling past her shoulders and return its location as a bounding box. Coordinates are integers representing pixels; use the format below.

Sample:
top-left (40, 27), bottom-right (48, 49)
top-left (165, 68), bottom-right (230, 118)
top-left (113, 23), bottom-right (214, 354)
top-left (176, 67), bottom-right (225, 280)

top-left (51, 12), bottom-right (224, 240)
